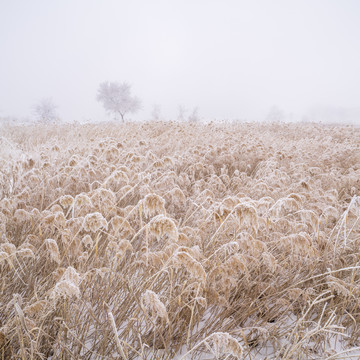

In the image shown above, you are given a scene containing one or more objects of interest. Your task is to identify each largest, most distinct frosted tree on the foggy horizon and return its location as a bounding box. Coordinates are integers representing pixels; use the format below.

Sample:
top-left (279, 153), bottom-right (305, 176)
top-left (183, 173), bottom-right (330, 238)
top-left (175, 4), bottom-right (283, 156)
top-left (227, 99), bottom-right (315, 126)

top-left (96, 82), bottom-right (141, 122)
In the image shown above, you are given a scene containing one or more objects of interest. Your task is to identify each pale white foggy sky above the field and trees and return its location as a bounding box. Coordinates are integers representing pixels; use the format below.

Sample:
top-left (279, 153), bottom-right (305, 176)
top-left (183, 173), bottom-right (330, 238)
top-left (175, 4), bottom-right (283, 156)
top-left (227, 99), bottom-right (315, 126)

top-left (0, 0), bottom-right (360, 121)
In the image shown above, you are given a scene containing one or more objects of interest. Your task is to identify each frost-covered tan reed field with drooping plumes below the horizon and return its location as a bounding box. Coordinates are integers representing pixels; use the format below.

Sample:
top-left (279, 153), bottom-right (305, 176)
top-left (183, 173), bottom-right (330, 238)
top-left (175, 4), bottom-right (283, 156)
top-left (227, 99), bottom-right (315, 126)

top-left (0, 122), bottom-right (360, 360)
